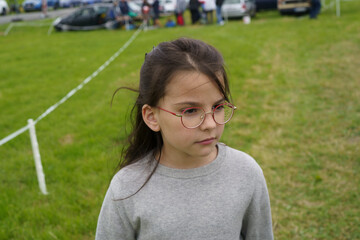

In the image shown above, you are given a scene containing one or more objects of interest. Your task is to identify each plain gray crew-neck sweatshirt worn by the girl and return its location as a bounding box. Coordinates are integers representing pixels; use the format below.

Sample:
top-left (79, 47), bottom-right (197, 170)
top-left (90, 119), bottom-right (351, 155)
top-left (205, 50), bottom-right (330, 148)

top-left (96, 143), bottom-right (273, 240)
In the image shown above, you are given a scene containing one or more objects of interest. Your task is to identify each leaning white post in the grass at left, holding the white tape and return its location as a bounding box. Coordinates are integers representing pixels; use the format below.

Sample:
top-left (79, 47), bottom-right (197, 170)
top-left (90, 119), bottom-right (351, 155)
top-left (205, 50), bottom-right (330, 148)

top-left (28, 119), bottom-right (48, 195)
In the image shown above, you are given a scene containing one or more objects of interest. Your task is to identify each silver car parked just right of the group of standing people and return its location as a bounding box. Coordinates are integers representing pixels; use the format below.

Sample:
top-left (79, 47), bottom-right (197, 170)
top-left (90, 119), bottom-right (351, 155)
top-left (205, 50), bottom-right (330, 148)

top-left (221, 0), bottom-right (256, 19)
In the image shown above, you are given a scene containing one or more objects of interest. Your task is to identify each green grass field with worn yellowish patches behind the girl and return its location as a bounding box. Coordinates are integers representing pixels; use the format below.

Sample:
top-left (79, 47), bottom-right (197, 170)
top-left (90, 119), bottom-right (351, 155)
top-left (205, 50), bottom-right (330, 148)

top-left (0, 1), bottom-right (360, 240)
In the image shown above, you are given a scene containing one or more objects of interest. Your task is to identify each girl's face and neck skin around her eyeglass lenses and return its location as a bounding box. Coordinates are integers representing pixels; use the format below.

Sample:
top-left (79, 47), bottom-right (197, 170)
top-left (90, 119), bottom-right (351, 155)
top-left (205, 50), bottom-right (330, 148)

top-left (154, 72), bottom-right (225, 168)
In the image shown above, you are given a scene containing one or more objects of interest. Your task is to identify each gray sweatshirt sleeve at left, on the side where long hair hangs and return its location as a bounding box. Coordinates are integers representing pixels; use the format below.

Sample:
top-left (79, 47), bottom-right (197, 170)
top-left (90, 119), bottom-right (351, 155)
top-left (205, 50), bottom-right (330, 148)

top-left (95, 186), bottom-right (135, 240)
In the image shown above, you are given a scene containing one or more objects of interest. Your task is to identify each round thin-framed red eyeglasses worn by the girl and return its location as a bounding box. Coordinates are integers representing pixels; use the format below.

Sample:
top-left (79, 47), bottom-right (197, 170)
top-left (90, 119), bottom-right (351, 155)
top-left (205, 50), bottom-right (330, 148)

top-left (158, 103), bottom-right (236, 129)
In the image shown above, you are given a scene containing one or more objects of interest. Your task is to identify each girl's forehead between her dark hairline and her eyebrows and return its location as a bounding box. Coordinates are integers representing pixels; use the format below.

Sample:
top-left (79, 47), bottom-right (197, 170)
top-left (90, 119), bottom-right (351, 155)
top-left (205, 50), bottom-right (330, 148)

top-left (164, 71), bottom-right (224, 101)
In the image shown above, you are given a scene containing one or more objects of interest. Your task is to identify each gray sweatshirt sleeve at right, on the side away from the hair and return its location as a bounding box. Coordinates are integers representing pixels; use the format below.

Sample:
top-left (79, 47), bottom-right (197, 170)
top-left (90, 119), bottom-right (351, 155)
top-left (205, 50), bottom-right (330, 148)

top-left (241, 170), bottom-right (274, 240)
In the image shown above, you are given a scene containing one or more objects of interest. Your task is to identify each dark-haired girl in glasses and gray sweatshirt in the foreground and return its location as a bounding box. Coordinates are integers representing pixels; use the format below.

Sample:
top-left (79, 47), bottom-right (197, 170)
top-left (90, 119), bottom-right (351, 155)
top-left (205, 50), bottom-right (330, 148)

top-left (96, 38), bottom-right (273, 240)
